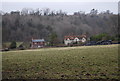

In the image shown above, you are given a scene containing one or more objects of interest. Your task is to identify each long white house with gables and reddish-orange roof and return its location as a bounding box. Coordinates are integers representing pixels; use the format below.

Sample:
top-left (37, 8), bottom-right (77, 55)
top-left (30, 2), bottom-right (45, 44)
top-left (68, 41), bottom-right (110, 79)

top-left (64, 35), bottom-right (87, 45)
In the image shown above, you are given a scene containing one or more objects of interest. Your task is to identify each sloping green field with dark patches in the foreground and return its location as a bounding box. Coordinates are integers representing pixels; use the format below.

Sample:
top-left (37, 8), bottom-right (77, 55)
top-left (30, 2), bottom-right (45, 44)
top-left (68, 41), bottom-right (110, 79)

top-left (2, 45), bottom-right (119, 79)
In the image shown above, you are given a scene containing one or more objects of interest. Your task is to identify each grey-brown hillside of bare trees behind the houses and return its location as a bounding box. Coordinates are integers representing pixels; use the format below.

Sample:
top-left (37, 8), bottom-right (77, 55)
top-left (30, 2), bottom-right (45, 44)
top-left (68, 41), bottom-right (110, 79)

top-left (2, 9), bottom-right (118, 42)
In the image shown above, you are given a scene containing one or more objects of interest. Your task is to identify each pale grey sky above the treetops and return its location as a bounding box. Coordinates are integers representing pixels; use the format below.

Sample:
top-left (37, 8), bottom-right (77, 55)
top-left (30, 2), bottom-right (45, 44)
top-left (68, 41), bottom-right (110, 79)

top-left (2, 2), bottom-right (118, 14)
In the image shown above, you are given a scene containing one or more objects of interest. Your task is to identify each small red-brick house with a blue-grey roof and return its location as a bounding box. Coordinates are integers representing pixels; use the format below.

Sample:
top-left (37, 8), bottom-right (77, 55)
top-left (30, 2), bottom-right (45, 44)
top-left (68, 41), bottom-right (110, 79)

top-left (31, 39), bottom-right (45, 48)
